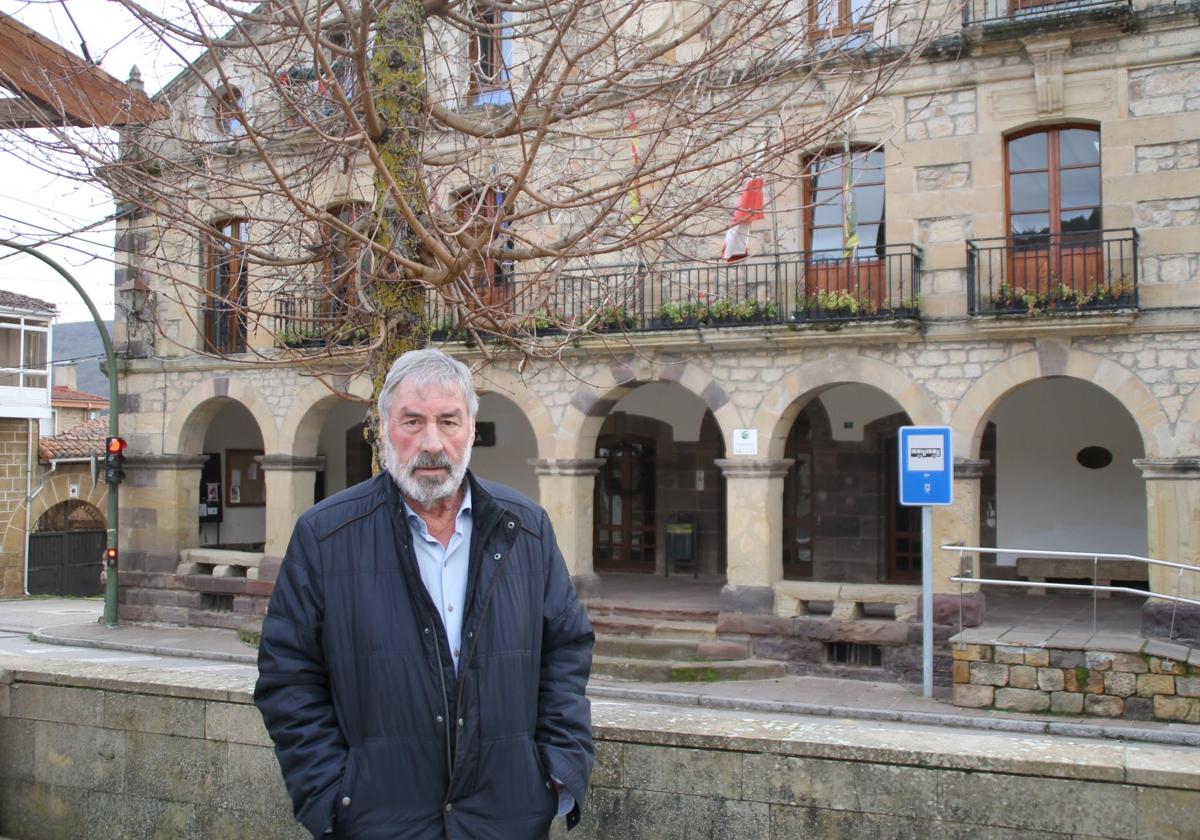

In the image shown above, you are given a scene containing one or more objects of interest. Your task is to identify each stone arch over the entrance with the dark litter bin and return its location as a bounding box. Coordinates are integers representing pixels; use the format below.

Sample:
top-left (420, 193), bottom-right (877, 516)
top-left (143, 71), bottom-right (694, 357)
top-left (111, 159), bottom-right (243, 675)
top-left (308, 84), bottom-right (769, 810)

top-left (554, 358), bottom-right (740, 458)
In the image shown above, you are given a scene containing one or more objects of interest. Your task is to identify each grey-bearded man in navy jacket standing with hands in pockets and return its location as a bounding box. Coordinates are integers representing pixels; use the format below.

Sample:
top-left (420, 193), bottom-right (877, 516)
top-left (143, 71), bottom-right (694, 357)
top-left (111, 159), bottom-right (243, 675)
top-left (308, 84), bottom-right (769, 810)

top-left (254, 350), bottom-right (593, 840)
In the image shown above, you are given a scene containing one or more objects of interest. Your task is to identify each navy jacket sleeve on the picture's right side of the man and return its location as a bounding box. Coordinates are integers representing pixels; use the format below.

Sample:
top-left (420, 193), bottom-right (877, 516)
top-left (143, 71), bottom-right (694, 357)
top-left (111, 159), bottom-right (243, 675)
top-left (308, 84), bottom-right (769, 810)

top-left (535, 512), bottom-right (595, 828)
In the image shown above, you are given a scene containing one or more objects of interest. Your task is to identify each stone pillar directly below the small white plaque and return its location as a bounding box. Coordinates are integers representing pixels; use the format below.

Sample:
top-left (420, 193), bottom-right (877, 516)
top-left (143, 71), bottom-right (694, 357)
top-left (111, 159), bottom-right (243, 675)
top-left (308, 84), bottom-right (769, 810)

top-left (716, 458), bottom-right (793, 614)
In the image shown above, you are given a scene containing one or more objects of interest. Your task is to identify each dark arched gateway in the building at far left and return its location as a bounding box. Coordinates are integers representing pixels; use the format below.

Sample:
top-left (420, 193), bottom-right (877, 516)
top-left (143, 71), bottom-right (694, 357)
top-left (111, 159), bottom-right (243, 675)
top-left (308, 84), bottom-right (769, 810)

top-left (29, 499), bottom-right (106, 596)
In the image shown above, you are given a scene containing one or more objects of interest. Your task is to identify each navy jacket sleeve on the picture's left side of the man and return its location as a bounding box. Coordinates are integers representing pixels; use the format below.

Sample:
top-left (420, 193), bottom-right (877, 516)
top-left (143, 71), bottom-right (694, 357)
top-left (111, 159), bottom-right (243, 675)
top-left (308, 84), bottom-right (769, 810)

top-left (254, 517), bottom-right (347, 838)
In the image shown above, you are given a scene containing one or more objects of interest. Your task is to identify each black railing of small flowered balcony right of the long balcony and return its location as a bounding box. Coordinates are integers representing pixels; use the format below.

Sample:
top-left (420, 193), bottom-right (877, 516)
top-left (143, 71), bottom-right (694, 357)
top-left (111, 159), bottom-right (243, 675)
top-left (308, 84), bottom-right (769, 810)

top-left (967, 228), bottom-right (1138, 316)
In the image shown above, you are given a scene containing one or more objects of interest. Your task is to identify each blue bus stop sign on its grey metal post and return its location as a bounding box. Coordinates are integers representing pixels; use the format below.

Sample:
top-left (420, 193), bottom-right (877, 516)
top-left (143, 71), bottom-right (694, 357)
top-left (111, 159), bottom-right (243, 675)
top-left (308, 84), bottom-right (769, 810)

top-left (899, 426), bottom-right (954, 697)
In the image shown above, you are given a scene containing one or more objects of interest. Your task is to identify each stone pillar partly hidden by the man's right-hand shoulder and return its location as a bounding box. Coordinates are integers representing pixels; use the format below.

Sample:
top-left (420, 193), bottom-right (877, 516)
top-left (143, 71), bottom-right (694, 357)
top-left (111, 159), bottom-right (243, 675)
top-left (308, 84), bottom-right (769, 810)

top-left (529, 458), bottom-right (605, 598)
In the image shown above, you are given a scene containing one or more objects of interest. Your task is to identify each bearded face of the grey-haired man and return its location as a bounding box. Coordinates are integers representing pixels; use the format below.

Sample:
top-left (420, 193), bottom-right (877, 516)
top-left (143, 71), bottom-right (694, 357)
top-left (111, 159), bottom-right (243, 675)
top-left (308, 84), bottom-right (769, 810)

top-left (383, 382), bottom-right (475, 509)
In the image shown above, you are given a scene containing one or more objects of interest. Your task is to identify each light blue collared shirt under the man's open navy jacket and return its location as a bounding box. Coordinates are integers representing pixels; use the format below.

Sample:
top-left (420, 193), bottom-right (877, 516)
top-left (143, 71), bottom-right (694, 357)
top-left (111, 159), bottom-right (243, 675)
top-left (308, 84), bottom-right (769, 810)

top-left (404, 485), bottom-right (470, 672)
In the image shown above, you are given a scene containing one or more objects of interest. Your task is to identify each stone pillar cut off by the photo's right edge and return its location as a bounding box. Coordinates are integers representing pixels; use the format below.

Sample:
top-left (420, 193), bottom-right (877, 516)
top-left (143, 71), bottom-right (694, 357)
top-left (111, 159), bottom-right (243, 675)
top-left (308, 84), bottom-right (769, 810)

top-left (1134, 456), bottom-right (1200, 642)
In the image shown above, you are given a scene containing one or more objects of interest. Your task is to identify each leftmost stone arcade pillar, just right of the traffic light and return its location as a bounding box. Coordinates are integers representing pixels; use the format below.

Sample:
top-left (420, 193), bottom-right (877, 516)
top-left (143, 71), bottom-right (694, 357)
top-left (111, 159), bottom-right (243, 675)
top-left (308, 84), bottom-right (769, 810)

top-left (118, 455), bottom-right (208, 574)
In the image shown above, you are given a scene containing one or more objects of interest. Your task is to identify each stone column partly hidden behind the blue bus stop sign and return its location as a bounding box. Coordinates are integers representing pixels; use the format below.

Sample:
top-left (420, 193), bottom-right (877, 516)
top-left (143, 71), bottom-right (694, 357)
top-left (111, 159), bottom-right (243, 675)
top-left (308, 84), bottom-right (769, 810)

top-left (931, 458), bottom-right (989, 628)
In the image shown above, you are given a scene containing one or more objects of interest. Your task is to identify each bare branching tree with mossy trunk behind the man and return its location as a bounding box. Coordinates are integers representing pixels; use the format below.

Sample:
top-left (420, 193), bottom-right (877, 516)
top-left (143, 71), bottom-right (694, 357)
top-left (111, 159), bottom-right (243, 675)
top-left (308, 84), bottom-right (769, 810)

top-left (0, 0), bottom-right (956, 393)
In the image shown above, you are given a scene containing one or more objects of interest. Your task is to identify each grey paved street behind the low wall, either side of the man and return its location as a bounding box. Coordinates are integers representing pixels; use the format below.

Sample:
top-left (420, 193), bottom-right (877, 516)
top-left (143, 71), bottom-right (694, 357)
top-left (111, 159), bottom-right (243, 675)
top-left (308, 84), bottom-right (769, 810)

top-left (0, 599), bottom-right (1200, 746)
